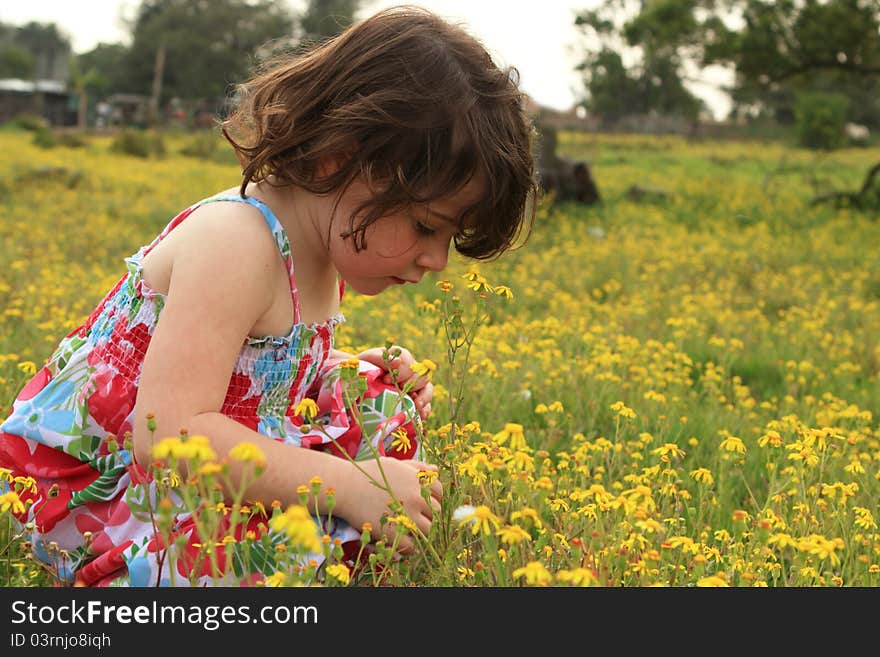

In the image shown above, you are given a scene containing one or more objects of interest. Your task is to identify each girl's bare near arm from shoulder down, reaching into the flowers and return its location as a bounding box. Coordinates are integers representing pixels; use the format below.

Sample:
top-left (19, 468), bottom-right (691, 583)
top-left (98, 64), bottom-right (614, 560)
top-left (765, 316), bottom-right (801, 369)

top-left (133, 202), bottom-right (433, 544)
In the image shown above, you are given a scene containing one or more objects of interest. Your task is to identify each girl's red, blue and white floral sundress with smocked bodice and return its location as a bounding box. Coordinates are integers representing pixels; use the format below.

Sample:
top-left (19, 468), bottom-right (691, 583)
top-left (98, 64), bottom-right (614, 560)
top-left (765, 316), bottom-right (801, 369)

top-left (0, 195), bottom-right (421, 586)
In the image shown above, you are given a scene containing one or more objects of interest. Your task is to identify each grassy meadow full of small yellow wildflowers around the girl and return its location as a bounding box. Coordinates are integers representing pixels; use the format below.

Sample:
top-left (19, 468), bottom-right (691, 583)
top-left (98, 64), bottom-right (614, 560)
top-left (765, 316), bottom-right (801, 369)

top-left (0, 129), bottom-right (880, 587)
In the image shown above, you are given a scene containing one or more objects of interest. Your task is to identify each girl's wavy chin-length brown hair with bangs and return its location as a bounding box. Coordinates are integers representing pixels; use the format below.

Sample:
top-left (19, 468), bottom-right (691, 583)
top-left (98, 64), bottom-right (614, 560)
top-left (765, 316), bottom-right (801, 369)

top-left (221, 6), bottom-right (537, 259)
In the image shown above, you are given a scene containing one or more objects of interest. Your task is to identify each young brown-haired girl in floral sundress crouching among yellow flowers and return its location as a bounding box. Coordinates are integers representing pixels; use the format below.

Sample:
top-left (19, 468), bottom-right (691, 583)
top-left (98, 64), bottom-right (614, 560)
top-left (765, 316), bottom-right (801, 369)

top-left (0, 8), bottom-right (535, 586)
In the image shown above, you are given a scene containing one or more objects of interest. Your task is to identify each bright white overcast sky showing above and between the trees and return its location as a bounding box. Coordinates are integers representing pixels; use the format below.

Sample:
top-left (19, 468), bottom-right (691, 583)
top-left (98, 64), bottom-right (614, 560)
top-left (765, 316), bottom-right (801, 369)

top-left (0, 0), bottom-right (727, 118)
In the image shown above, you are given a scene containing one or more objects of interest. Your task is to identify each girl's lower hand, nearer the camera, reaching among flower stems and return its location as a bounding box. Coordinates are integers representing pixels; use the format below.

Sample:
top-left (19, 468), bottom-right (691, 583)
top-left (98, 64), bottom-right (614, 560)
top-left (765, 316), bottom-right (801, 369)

top-left (337, 456), bottom-right (443, 554)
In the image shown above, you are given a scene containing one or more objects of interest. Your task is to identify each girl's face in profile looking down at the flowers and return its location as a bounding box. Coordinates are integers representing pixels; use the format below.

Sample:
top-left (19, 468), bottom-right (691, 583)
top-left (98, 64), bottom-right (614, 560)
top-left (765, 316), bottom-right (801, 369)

top-left (330, 177), bottom-right (481, 295)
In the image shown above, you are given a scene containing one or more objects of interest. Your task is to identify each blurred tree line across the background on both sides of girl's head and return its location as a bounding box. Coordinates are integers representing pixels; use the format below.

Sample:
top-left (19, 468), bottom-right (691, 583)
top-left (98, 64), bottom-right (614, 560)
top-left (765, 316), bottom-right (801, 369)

top-left (0, 0), bottom-right (880, 144)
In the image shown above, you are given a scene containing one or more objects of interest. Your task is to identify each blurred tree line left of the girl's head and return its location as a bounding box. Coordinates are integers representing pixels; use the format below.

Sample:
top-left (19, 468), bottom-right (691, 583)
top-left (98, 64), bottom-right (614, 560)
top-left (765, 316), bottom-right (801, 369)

top-left (0, 0), bottom-right (362, 124)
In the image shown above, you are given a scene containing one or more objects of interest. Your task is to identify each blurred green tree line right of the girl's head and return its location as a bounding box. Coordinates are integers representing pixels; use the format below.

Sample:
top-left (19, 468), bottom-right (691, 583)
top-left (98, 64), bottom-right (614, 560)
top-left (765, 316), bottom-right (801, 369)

top-left (576, 0), bottom-right (880, 134)
